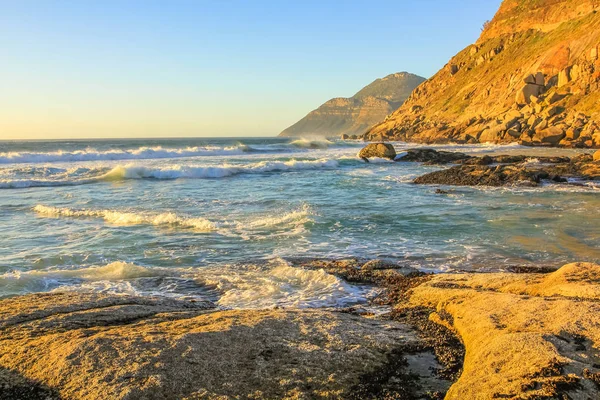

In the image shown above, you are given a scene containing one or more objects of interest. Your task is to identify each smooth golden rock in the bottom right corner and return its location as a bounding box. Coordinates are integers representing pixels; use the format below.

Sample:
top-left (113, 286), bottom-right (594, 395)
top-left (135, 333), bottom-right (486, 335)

top-left (410, 264), bottom-right (600, 400)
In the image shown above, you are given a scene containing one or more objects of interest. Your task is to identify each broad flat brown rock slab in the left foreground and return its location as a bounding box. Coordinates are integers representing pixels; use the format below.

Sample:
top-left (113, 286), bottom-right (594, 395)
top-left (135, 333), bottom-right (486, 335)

top-left (0, 292), bottom-right (449, 399)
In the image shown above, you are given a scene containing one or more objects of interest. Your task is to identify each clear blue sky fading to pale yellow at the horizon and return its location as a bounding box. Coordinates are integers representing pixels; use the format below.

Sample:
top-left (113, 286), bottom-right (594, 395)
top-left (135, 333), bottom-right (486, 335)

top-left (0, 0), bottom-right (500, 139)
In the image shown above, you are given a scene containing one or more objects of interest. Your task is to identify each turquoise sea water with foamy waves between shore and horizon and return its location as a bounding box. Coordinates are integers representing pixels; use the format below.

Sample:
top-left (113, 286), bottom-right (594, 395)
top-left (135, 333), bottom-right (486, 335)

top-left (0, 138), bottom-right (600, 307)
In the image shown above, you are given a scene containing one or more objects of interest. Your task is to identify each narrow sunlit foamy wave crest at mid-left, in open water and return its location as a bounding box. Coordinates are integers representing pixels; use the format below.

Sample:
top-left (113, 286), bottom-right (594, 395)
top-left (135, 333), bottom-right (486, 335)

top-left (33, 204), bottom-right (216, 232)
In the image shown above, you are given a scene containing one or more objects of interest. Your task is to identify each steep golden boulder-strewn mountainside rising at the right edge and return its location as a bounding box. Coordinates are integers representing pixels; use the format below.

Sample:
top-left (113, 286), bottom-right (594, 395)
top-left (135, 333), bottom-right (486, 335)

top-left (364, 0), bottom-right (600, 147)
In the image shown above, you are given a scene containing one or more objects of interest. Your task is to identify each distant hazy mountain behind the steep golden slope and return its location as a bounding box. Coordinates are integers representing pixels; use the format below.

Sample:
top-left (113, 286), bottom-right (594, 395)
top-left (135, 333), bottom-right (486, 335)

top-left (279, 72), bottom-right (425, 137)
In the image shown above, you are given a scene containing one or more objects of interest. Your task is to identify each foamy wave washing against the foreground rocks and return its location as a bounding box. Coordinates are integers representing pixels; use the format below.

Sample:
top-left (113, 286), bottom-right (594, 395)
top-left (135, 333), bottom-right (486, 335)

top-left (0, 260), bottom-right (376, 309)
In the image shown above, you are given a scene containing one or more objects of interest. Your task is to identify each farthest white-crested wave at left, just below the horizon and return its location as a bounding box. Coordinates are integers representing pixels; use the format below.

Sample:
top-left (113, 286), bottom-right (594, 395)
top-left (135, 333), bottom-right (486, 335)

top-left (0, 144), bottom-right (251, 164)
